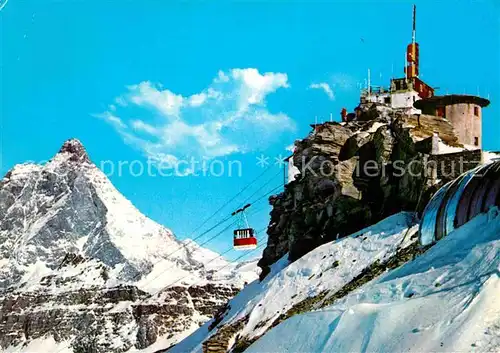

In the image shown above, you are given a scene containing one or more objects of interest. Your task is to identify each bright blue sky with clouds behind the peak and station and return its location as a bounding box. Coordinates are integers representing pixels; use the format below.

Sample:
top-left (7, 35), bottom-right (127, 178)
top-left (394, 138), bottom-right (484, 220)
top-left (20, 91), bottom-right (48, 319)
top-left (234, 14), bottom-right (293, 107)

top-left (0, 0), bottom-right (500, 258)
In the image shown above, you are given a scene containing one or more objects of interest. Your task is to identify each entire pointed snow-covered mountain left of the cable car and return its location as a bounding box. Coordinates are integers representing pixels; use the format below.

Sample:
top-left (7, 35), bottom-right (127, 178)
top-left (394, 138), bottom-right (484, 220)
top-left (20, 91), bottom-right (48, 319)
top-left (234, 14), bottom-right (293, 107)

top-left (0, 139), bottom-right (257, 352)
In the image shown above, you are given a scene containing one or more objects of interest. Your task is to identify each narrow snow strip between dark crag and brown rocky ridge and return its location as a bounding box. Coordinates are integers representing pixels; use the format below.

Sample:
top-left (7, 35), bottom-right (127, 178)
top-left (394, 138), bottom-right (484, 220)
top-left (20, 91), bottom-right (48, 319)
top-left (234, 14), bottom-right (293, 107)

top-left (169, 213), bottom-right (418, 353)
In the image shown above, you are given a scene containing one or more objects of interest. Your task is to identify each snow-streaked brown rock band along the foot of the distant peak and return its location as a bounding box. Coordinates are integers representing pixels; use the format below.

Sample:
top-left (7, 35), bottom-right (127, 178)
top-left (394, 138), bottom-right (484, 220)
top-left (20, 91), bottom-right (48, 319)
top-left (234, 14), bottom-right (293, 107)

top-left (0, 254), bottom-right (238, 352)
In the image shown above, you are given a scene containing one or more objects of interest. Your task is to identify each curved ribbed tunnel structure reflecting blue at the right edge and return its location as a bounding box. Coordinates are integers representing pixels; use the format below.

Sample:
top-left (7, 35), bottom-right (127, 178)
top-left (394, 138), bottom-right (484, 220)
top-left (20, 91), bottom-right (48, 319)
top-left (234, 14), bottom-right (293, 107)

top-left (420, 160), bottom-right (500, 245)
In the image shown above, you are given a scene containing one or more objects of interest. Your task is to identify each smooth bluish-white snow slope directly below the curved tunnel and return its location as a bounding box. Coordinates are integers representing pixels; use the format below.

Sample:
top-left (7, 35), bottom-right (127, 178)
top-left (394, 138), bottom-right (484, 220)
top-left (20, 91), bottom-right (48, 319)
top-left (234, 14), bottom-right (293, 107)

top-left (246, 208), bottom-right (500, 353)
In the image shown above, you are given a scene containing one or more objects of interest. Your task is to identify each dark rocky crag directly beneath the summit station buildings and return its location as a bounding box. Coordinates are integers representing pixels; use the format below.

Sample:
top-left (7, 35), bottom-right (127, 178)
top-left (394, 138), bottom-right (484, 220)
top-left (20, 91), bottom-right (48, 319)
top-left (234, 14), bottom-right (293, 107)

top-left (259, 103), bottom-right (468, 278)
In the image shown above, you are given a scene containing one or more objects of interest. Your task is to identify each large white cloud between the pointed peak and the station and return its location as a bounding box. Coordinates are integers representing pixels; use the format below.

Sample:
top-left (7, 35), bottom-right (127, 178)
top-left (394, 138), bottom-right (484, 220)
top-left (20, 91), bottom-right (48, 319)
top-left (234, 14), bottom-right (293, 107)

top-left (96, 68), bottom-right (294, 168)
